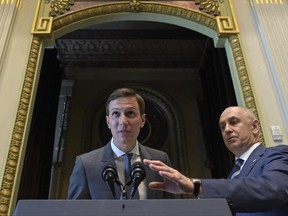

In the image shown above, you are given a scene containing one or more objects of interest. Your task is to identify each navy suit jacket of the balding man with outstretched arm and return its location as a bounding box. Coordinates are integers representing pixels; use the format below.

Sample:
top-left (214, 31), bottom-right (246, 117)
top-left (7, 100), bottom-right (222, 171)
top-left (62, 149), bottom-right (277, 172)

top-left (200, 145), bottom-right (288, 215)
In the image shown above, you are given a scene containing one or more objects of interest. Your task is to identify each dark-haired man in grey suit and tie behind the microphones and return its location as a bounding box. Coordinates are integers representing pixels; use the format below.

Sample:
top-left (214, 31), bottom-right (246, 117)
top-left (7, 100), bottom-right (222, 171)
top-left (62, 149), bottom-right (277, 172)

top-left (68, 88), bottom-right (174, 199)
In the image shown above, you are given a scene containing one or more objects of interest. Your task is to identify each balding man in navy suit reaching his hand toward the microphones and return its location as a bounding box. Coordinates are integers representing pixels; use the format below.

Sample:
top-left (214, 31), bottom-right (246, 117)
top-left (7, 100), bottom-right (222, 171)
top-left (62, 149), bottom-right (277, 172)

top-left (144, 107), bottom-right (288, 216)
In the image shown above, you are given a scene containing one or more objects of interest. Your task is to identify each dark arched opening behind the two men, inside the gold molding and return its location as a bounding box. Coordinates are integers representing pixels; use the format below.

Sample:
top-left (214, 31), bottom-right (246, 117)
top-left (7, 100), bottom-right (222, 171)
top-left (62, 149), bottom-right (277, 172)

top-left (18, 22), bottom-right (236, 199)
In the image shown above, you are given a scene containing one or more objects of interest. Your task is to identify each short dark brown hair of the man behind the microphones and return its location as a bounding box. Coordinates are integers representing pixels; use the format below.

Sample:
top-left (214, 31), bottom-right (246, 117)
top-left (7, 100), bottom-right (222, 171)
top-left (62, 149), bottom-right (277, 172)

top-left (106, 88), bottom-right (145, 115)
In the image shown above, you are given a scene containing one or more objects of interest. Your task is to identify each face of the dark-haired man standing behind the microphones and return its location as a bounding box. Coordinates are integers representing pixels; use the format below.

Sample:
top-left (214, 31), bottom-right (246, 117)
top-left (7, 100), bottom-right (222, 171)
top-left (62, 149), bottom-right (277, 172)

top-left (106, 97), bottom-right (145, 152)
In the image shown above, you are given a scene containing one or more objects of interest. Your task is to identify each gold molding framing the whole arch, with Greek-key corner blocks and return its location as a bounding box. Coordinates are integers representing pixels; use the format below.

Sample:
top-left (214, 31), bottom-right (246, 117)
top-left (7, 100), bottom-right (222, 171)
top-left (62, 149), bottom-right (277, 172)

top-left (0, 0), bottom-right (258, 216)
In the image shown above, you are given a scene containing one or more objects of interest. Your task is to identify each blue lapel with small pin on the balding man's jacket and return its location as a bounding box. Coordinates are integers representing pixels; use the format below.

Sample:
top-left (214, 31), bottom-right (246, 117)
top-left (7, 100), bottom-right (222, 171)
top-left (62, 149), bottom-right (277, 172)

top-left (239, 145), bottom-right (266, 177)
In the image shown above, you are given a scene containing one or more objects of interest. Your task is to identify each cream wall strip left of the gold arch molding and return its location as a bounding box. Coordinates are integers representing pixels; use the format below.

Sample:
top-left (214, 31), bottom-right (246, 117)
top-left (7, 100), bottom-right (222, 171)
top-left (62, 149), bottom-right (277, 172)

top-left (0, 0), bottom-right (37, 190)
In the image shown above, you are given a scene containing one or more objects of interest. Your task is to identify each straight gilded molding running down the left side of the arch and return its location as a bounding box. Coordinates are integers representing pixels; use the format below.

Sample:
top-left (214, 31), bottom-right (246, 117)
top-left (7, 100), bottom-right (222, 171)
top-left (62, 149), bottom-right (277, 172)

top-left (0, 36), bottom-right (41, 216)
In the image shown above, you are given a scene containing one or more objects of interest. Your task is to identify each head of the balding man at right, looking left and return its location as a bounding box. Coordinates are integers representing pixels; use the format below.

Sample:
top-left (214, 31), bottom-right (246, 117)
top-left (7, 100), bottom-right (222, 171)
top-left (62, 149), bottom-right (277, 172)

top-left (219, 107), bottom-right (259, 157)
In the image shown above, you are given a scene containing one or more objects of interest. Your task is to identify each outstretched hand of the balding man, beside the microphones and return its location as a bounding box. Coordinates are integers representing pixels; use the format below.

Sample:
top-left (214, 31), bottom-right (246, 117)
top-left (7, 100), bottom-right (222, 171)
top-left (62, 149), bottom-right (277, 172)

top-left (143, 159), bottom-right (194, 194)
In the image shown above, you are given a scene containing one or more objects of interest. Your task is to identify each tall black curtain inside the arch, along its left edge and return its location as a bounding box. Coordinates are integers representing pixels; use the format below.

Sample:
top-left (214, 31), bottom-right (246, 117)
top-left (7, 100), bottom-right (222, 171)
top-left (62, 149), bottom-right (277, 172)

top-left (18, 49), bottom-right (62, 199)
